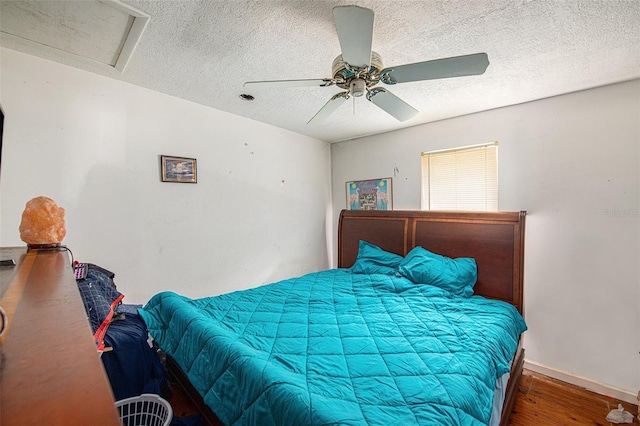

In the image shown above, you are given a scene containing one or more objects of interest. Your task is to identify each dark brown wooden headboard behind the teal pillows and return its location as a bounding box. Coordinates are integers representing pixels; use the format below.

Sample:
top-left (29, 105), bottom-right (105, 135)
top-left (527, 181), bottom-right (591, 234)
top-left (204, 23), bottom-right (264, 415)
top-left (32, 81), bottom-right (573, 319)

top-left (338, 210), bottom-right (526, 314)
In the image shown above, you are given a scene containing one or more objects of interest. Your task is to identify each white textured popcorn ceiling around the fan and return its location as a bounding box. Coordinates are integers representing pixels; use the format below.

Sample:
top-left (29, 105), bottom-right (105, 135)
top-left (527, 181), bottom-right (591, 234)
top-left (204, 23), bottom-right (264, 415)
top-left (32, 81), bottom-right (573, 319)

top-left (0, 0), bottom-right (640, 142)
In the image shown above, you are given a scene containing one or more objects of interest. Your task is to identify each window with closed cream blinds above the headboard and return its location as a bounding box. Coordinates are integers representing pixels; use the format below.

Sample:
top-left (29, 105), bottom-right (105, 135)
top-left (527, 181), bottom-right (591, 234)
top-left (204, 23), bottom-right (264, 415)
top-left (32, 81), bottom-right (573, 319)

top-left (422, 142), bottom-right (498, 211)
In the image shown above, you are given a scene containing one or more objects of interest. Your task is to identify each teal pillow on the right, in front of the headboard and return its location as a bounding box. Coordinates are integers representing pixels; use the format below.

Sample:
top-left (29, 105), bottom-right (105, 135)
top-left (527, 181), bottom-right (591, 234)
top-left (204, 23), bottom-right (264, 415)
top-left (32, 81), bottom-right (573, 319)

top-left (398, 246), bottom-right (478, 297)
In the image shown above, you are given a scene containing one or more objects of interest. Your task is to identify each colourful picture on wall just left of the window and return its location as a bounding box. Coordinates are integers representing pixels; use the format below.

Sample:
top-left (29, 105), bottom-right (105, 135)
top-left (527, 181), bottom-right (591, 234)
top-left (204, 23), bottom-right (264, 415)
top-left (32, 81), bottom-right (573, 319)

top-left (347, 178), bottom-right (393, 210)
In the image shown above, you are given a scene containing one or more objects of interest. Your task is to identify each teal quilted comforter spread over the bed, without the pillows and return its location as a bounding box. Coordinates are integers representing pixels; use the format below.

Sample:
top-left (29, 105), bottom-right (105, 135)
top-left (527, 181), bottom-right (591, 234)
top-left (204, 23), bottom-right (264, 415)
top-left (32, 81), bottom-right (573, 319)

top-left (140, 269), bottom-right (526, 426)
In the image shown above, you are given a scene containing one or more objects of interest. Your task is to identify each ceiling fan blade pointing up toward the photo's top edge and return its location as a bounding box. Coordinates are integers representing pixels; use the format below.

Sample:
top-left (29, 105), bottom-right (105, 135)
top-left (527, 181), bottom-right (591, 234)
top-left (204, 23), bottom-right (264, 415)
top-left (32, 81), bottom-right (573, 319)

top-left (333, 6), bottom-right (374, 68)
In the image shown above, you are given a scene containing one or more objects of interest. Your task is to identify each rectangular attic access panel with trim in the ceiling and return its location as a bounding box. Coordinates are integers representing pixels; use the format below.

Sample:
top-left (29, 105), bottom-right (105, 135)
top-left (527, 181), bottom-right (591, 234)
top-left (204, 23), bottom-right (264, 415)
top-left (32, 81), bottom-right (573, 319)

top-left (0, 0), bottom-right (149, 72)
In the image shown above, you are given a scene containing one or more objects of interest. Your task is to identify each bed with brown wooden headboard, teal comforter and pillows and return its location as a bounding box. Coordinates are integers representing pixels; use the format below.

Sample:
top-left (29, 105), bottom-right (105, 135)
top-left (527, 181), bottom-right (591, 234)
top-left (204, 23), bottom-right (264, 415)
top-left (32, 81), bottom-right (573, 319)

top-left (141, 210), bottom-right (526, 425)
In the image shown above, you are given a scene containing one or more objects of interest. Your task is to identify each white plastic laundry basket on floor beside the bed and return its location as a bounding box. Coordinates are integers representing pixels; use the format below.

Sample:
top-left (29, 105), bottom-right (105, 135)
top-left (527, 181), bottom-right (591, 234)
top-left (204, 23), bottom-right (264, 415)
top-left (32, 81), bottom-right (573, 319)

top-left (116, 393), bottom-right (173, 426)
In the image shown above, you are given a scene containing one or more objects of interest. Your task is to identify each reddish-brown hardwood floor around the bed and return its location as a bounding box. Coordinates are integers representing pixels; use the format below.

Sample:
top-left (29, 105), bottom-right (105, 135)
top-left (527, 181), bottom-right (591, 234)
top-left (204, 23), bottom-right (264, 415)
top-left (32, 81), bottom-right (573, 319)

top-left (169, 370), bottom-right (638, 426)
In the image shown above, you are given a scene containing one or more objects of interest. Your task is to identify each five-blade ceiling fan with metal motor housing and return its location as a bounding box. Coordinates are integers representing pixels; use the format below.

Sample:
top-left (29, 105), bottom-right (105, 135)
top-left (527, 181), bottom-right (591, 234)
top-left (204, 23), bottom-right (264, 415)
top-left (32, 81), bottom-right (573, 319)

top-left (244, 6), bottom-right (489, 124)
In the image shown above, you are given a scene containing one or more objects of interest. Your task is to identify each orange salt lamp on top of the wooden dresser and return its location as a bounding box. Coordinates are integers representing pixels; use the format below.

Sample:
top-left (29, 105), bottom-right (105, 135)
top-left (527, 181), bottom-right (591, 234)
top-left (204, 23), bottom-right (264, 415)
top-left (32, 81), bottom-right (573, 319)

top-left (20, 197), bottom-right (67, 246)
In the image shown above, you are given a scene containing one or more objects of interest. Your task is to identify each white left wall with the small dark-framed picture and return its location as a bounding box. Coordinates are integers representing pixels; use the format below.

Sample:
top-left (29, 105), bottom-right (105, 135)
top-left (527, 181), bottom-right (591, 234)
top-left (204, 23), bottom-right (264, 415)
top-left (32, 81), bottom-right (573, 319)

top-left (0, 49), bottom-right (331, 303)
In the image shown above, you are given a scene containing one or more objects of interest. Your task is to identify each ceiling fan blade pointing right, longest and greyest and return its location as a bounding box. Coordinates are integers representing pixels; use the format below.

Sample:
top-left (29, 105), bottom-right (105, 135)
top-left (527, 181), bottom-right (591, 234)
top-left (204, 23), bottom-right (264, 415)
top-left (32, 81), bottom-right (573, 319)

top-left (380, 53), bottom-right (489, 84)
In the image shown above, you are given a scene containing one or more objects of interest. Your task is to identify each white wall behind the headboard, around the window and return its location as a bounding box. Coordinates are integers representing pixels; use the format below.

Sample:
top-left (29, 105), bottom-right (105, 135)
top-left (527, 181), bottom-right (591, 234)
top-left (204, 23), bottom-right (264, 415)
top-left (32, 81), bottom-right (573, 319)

top-left (332, 80), bottom-right (640, 395)
